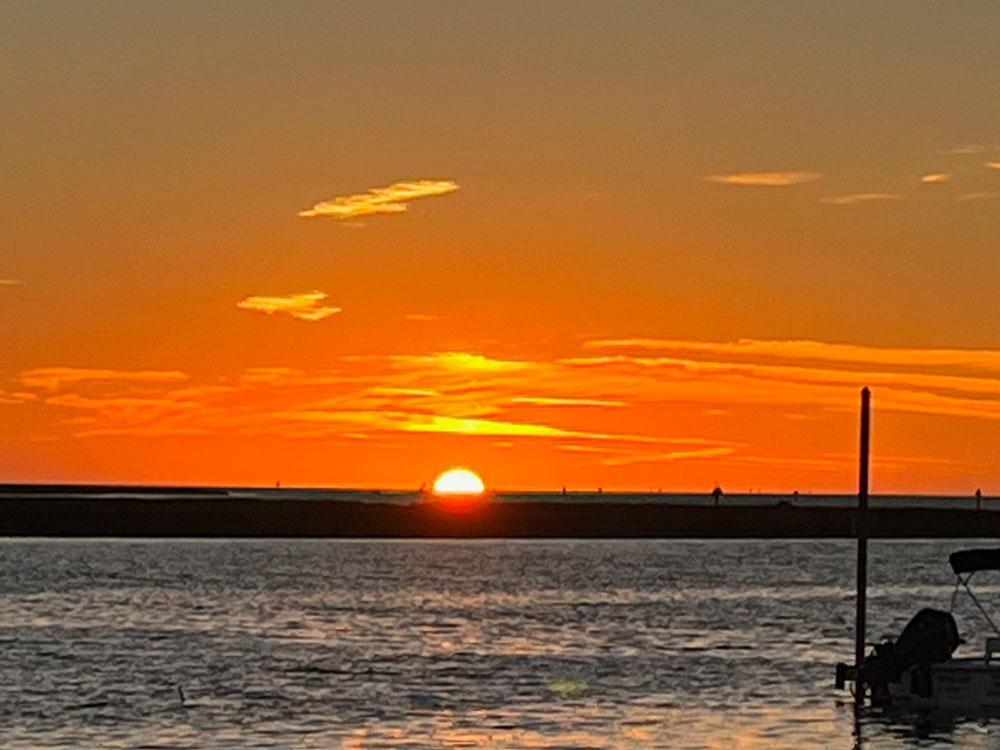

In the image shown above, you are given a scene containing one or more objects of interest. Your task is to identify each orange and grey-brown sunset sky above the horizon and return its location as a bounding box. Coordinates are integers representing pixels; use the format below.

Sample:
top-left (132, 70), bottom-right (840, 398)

top-left (0, 0), bottom-right (1000, 495)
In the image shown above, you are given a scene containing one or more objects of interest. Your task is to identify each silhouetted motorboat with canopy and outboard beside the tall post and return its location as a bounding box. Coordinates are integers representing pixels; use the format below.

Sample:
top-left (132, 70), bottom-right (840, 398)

top-left (836, 549), bottom-right (1000, 714)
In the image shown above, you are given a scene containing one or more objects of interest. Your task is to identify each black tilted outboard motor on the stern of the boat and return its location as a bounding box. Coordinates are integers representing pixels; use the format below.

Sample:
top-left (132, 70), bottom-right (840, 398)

top-left (864, 609), bottom-right (962, 702)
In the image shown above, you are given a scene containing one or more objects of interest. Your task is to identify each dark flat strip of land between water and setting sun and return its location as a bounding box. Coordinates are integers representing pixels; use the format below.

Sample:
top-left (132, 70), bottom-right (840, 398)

top-left (0, 485), bottom-right (1000, 539)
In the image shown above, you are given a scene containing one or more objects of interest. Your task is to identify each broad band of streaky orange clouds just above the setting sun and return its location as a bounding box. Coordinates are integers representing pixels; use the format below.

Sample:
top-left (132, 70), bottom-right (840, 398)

top-left (9, 338), bottom-right (1000, 494)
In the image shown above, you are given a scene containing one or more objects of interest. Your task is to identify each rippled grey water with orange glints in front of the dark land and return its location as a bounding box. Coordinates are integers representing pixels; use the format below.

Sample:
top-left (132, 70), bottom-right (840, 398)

top-left (0, 540), bottom-right (1000, 748)
